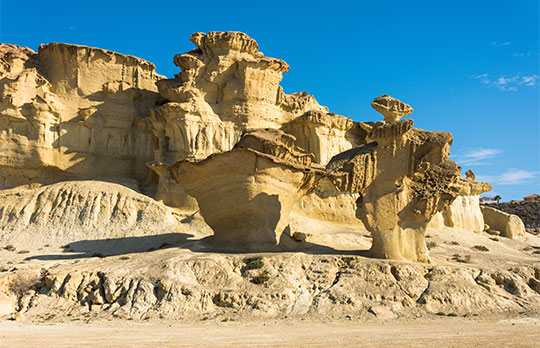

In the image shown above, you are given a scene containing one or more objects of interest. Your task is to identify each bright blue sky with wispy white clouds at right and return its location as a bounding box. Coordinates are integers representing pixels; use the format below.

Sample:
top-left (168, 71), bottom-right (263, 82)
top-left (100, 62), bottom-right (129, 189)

top-left (0, 0), bottom-right (540, 201)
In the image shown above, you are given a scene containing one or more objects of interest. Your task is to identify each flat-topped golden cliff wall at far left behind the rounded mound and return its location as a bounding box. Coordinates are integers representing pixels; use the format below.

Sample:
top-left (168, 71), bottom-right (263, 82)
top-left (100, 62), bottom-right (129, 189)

top-left (0, 43), bottom-right (162, 188)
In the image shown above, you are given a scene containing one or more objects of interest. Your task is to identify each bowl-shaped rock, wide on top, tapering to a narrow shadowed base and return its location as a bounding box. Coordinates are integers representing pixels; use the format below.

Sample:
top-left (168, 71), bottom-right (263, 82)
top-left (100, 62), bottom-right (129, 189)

top-left (169, 129), bottom-right (325, 250)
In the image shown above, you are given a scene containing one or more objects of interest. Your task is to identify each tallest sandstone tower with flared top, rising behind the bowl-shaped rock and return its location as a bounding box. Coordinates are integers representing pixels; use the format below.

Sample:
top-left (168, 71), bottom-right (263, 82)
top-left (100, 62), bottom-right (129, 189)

top-left (148, 32), bottom-right (327, 206)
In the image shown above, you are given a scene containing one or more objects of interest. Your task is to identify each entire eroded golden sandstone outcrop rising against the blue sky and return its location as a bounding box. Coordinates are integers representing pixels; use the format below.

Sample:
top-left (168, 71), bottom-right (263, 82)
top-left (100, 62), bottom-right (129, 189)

top-left (0, 32), bottom-right (522, 262)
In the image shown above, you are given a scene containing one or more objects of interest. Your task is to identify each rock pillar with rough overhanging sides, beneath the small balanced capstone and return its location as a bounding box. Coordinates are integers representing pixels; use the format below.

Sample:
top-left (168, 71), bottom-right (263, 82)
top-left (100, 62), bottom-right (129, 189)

top-left (327, 98), bottom-right (460, 262)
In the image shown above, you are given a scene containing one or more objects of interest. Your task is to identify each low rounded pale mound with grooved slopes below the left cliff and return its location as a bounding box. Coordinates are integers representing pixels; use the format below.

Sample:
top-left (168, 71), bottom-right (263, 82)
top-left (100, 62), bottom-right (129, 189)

top-left (0, 181), bottom-right (188, 253)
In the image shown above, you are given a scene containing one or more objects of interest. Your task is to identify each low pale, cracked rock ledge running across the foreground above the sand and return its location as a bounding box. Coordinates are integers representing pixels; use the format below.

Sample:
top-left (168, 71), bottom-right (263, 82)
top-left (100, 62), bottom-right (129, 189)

top-left (0, 251), bottom-right (540, 322)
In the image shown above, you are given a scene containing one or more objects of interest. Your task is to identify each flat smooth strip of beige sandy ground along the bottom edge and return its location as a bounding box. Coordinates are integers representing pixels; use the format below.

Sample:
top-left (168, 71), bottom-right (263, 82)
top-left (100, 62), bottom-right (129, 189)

top-left (0, 318), bottom-right (540, 348)
